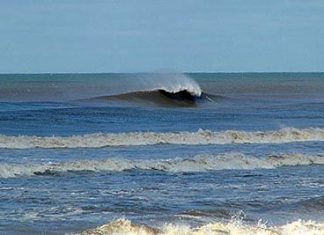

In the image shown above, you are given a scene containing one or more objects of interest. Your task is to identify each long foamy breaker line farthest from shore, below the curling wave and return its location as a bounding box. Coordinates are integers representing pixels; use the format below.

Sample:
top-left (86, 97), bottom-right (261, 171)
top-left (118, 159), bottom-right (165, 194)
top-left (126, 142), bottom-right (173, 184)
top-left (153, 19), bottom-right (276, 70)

top-left (0, 128), bottom-right (324, 149)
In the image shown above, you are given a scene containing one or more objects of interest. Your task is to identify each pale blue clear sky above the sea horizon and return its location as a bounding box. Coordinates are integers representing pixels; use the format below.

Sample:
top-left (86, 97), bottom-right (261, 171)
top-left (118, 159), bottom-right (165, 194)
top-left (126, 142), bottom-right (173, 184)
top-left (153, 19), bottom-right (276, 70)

top-left (0, 0), bottom-right (324, 73)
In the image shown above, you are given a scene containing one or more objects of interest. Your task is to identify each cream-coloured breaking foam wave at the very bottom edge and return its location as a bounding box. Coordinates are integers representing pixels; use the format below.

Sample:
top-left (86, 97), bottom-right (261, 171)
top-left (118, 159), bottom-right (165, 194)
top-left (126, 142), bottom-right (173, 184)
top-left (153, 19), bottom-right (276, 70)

top-left (79, 219), bottom-right (324, 235)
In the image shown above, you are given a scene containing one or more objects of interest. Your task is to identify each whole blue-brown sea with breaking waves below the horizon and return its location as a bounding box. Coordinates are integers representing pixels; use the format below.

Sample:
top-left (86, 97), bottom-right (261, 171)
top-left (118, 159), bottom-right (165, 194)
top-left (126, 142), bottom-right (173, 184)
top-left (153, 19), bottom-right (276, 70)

top-left (0, 73), bottom-right (324, 235)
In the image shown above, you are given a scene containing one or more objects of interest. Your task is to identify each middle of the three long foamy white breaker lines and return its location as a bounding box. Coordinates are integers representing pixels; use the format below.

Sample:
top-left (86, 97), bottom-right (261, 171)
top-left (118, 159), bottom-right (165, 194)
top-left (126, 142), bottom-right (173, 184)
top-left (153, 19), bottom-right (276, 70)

top-left (0, 153), bottom-right (324, 178)
